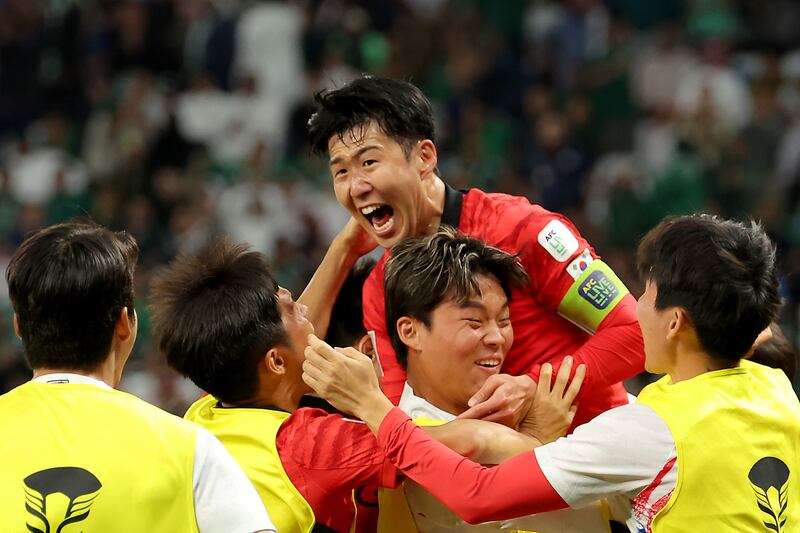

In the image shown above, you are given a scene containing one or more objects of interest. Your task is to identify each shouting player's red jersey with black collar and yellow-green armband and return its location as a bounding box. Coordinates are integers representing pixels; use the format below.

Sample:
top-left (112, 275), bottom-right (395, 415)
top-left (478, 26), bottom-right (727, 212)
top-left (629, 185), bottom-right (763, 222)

top-left (363, 187), bottom-right (644, 427)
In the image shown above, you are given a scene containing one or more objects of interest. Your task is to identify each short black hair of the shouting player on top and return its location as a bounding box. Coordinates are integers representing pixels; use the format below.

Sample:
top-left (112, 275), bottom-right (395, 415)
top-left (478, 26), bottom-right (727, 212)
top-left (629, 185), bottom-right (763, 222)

top-left (308, 76), bottom-right (436, 157)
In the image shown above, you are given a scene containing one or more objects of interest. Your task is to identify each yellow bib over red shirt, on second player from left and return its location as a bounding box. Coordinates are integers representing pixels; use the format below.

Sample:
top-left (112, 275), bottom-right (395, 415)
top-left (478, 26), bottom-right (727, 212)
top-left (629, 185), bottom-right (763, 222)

top-left (184, 396), bottom-right (315, 533)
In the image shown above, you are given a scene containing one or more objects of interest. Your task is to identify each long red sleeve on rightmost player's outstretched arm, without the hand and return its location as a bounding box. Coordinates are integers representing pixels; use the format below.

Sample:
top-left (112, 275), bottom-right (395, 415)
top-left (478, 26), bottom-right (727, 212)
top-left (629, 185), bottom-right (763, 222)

top-left (378, 408), bottom-right (567, 524)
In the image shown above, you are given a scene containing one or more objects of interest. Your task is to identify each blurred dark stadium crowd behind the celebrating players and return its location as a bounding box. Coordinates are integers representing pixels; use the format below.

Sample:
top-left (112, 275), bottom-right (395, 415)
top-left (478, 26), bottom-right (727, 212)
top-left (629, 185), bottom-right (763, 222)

top-left (0, 0), bottom-right (800, 414)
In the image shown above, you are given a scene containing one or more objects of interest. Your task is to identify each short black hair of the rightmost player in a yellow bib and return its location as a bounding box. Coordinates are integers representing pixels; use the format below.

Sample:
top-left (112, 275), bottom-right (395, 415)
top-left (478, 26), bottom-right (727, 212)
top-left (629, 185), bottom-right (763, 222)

top-left (637, 215), bottom-right (781, 363)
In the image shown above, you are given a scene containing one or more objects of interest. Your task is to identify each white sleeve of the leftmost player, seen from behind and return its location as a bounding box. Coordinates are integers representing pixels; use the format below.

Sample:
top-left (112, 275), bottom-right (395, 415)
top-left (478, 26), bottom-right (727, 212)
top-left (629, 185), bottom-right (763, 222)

top-left (193, 428), bottom-right (276, 533)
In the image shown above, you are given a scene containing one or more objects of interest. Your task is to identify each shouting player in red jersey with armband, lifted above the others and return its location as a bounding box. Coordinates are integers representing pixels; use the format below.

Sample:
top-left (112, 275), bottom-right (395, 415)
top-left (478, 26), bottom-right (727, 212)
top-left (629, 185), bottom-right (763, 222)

top-left (301, 77), bottom-right (644, 425)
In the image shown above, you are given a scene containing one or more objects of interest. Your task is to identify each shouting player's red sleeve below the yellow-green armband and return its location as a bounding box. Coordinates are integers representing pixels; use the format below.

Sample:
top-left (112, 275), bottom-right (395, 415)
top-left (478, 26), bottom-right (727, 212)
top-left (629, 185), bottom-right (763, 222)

top-left (529, 294), bottom-right (644, 394)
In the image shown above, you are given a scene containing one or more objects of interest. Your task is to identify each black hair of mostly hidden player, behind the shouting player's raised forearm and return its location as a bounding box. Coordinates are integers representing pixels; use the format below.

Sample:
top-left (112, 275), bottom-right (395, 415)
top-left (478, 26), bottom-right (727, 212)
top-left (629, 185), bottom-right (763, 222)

top-left (325, 257), bottom-right (375, 347)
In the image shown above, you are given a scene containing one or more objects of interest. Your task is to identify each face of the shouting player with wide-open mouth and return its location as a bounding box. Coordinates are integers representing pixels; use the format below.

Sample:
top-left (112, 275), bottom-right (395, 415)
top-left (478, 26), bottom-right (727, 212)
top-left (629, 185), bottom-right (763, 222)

top-left (328, 123), bottom-right (429, 248)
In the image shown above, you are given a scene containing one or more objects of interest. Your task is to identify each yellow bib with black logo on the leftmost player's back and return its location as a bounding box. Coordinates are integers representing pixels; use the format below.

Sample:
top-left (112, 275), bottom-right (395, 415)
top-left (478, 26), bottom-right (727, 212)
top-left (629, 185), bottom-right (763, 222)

top-left (0, 382), bottom-right (198, 533)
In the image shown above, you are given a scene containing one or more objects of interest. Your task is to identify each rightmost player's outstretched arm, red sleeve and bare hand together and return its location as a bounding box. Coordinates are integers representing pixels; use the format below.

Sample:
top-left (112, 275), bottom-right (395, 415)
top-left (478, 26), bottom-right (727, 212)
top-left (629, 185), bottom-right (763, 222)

top-left (303, 336), bottom-right (567, 523)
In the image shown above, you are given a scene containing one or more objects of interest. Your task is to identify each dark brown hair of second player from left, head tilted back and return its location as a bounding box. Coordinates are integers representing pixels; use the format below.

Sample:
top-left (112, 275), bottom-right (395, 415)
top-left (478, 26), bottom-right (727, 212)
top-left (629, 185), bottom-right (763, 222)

top-left (150, 239), bottom-right (288, 403)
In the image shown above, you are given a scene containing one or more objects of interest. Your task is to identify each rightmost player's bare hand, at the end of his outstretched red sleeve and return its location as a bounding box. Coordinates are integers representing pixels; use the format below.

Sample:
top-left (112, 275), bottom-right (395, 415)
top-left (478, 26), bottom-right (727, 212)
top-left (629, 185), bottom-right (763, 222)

top-left (303, 335), bottom-right (391, 422)
